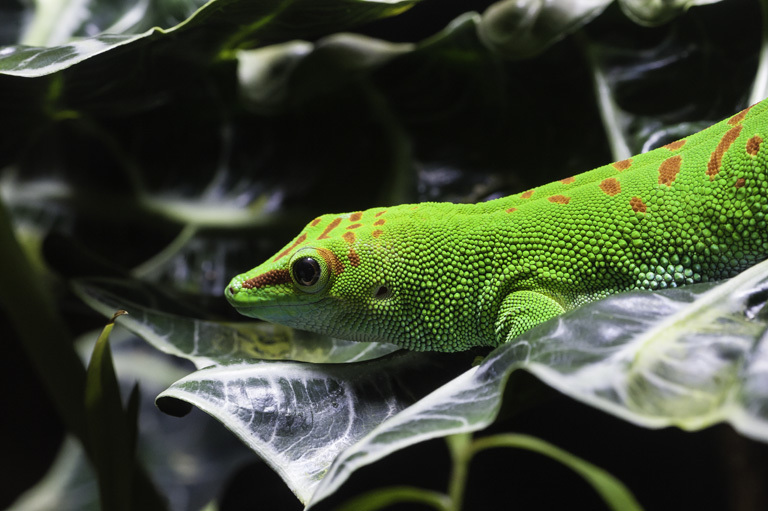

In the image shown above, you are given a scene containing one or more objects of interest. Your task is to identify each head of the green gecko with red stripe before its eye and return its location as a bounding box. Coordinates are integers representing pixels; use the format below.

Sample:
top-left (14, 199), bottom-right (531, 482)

top-left (225, 213), bottom-right (396, 341)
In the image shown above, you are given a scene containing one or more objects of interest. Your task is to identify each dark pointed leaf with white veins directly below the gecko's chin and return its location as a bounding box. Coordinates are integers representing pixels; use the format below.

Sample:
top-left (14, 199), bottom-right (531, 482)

top-left (157, 352), bottom-right (470, 502)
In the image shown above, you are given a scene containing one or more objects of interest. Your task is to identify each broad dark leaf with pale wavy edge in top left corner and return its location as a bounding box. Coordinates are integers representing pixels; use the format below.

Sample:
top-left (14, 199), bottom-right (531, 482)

top-left (0, 0), bottom-right (418, 78)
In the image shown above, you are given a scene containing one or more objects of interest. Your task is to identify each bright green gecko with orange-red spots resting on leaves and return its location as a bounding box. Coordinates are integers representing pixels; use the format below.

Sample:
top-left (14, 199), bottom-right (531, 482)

top-left (225, 100), bottom-right (768, 351)
